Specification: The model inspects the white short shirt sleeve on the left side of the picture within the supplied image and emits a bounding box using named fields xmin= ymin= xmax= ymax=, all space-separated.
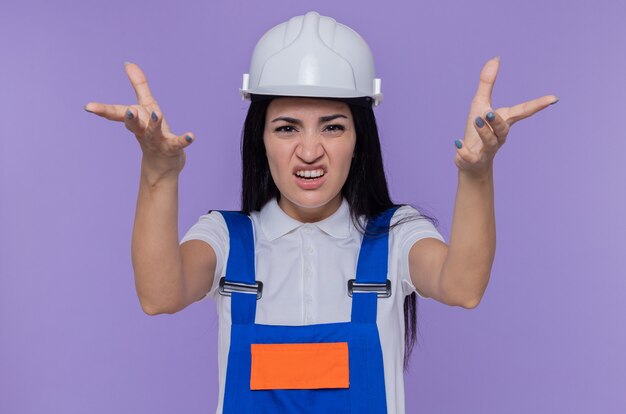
xmin=179 ymin=211 xmax=230 ymax=300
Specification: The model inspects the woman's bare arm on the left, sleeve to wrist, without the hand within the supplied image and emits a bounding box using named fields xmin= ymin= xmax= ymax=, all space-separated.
xmin=132 ymin=165 xmax=216 ymax=315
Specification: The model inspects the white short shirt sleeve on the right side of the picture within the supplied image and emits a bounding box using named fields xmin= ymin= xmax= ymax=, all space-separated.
xmin=390 ymin=205 xmax=445 ymax=299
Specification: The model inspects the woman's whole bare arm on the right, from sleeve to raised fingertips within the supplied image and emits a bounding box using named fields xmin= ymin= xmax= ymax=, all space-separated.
xmin=409 ymin=58 xmax=558 ymax=308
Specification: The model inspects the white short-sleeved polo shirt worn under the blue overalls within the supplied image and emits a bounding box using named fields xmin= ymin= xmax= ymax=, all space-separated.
xmin=180 ymin=199 xmax=444 ymax=414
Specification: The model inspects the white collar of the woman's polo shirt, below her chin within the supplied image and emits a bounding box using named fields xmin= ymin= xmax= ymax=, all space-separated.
xmin=260 ymin=198 xmax=351 ymax=241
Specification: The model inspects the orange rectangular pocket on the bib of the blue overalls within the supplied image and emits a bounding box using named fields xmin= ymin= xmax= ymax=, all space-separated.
xmin=250 ymin=342 xmax=350 ymax=390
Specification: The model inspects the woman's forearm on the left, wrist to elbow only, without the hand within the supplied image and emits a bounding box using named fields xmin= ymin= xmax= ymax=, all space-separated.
xmin=132 ymin=161 xmax=185 ymax=314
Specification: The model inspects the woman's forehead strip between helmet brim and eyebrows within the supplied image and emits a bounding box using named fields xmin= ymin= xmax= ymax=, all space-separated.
xmin=267 ymin=97 xmax=350 ymax=117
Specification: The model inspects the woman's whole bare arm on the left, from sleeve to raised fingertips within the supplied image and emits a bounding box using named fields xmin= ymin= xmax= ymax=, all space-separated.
xmin=85 ymin=60 xmax=215 ymax=315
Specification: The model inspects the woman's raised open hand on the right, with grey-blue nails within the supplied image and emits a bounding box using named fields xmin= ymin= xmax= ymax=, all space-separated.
xmin=454 ymin=57 xmax=558 ymax=176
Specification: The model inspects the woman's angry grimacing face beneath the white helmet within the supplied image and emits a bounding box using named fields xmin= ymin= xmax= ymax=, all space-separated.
xmin=263 ymin=98 xmax=356 ymax=222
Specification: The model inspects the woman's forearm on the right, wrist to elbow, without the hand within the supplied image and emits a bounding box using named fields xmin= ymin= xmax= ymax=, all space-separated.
xmin=439 ymin=167 xmax=496 ymax=307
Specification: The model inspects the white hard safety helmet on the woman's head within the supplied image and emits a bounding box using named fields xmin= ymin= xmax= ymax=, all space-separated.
xmin=240 ymin=11 xmax=383 ymax=105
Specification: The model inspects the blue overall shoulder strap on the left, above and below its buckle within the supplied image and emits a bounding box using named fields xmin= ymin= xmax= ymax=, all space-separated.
xmin=220 ymin=211 xmax=257 ymax=324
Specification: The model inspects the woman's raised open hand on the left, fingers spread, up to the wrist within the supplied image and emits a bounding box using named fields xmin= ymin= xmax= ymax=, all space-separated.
xmin=85 ymin=63 xmax=193 ymax=178
